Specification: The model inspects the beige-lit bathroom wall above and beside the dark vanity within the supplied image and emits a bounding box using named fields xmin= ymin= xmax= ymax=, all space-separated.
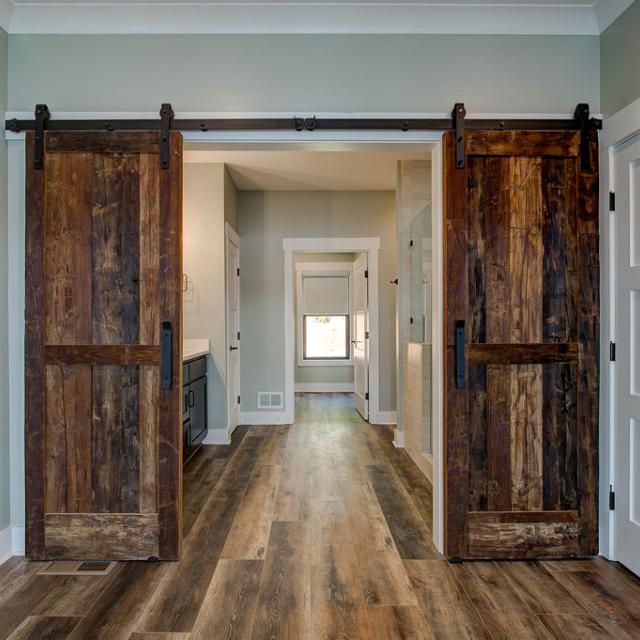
xmin=183 ymin=163 xmax=236 ymax=436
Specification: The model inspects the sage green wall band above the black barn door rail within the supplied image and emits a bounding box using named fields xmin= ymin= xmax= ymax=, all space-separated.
xmin=9 ymin=35 xmax=600 ymax=113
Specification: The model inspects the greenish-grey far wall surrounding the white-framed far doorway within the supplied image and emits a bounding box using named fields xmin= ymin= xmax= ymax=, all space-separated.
xmin=238 ymin=191 xmax=396 ymax=411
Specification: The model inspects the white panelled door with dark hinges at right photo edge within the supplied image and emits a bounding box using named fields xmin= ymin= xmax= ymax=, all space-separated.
xmin=612 ymin=137 xmax=640 ymax=574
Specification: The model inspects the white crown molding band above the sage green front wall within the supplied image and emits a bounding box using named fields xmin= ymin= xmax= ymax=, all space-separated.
xmin=0 ymin=0 xmax=632 ymax=35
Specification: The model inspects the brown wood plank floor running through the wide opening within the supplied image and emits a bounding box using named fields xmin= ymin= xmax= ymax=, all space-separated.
xmin=0 ymin=395 xmax=640 ymax=640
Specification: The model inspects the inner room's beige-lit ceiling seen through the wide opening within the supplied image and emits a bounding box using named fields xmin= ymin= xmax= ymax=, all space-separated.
xmin=184 ymin=150 xmax=426 ymax=191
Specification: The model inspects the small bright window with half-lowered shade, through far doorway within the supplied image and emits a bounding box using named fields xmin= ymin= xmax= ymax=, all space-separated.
xmin=296 ymin=263 xmax=351 ymax=366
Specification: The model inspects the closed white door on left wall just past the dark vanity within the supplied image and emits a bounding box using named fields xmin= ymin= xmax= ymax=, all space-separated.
xmin=226 ymin=227 xmax=240 ymax=429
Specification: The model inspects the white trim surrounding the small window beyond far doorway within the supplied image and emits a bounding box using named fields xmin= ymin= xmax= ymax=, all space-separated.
xmin=294 ymin=261 xmax=353 ymax=367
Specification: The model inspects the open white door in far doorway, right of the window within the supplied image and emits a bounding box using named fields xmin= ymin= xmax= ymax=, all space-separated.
xmin=351 ymin=253 xmax=369 ymax=420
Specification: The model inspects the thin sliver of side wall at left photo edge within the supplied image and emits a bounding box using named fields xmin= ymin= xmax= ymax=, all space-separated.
xmin=0 ymin=29 xmax=11 ymax=531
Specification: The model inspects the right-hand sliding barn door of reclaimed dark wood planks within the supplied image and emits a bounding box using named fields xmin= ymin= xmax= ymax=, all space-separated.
xmin=444 ymin=131 xmax=599 ymax=558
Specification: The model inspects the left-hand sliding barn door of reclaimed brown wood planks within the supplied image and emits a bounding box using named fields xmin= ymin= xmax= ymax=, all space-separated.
xmin=25 ymin=132 xmax=182 ymax=560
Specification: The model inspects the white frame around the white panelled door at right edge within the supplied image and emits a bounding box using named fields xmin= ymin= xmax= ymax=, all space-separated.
xmin=599 ymin=99 xmax=640 ymax=560
